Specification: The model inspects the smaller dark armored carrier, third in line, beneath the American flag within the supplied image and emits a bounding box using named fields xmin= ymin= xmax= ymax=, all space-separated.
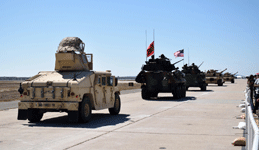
xmin=182 ymin=63 xmax=207 ymax=91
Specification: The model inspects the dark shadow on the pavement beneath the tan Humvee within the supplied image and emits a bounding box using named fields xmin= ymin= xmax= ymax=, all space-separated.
xmin=23 ymin=113 xmax=130 ymax=128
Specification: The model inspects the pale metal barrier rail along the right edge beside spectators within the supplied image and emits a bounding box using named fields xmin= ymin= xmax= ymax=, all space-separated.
xmin=245 ymin=87 xmax=259 ymax=150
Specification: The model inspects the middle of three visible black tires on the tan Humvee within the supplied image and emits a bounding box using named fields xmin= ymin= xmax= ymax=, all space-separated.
xmin=79 ymin=97 xmax=92 ymax=123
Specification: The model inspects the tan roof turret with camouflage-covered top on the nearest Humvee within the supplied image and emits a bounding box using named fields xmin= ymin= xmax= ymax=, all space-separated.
xmin=55 ymin=37 xmax=93 ymax=71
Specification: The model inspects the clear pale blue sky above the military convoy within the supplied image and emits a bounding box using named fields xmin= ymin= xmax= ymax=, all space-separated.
xmin=0 ymin=0 xmax=259 ymax=77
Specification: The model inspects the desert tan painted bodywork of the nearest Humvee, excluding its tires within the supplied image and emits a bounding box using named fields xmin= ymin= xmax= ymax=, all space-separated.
xmin=18 ymin=53 xmax=119 ymax=111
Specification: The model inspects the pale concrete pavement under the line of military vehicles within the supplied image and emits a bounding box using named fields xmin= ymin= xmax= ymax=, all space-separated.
xmin=0 ymin=79 xmax=246 ymax=150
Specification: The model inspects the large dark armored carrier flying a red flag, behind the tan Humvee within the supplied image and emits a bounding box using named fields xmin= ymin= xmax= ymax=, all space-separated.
xmin=135 ymin=54 xmax=186 ymax=99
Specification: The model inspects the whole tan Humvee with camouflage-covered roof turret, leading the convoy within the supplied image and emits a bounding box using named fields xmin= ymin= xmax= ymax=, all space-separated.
xmin=18 ymin=37 xmax=121 ymax=122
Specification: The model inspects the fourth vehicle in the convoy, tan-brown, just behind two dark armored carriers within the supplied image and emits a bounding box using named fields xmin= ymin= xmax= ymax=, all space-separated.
xmin=206 ymin=68 xmax=227 ymax=86
